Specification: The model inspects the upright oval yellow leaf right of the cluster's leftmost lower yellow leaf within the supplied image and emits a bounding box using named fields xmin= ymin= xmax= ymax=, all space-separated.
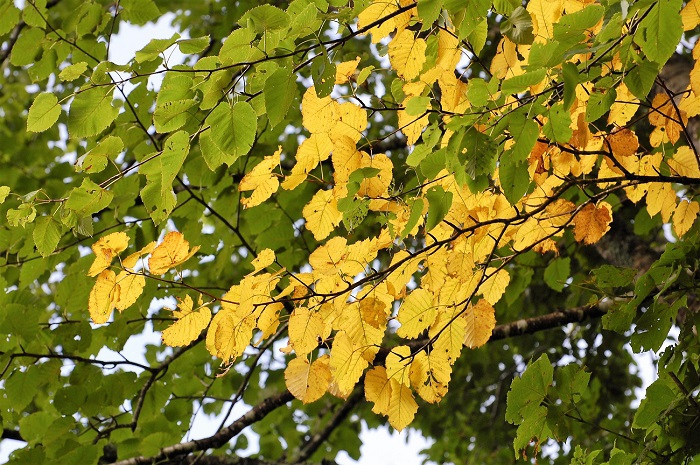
xmin=206 ymin=309 xmax=255 ymax=364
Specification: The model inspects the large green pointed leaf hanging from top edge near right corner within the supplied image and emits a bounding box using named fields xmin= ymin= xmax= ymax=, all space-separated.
xmin=634 ymin=0 xmax=683 ymax=65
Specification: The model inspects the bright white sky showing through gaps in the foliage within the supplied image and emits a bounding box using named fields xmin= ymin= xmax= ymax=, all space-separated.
xmin=0 ymin=10 xmax=677 ymax=465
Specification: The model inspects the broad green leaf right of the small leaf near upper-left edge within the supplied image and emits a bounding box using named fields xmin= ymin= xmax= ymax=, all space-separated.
xmin=68 ymin=87 xmax=119 ymax=138
